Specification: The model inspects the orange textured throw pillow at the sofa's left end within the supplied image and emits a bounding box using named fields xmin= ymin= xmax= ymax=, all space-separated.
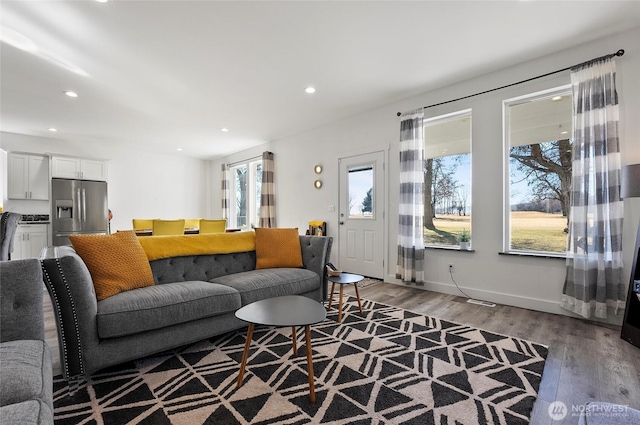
xmin=69 ymin=231 xmax=154 ymax=301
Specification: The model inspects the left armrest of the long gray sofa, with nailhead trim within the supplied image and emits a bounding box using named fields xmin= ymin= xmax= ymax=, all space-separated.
xmin=41 ymin=246 xmax=99 ymax=379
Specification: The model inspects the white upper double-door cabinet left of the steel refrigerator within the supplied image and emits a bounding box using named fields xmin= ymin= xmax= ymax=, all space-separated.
xmin=7 ymin=152 xmax=49 ymax=201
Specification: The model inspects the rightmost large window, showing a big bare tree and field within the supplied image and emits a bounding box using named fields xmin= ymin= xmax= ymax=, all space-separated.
xmin=504 ymin=86 xmax=572 ymax=254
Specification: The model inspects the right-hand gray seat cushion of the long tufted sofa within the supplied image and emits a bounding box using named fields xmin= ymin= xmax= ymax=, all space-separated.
xmin=211 ymin=268 xmax=320 ymax=305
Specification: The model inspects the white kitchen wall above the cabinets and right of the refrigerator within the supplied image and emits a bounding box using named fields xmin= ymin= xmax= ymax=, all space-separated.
xmin=0 ymin=133 xmax=210 ymax=232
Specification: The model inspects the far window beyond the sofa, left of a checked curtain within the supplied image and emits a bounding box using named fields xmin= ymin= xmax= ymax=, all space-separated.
xmin=229 ymin=161 xmax=262 ymax=229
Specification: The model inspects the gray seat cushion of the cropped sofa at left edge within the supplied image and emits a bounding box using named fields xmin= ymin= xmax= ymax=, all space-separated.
xmin=0 ymin=340 xmax=53 ymax=409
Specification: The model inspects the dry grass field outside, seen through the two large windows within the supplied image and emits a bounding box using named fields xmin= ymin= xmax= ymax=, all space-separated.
xmin=424 ymin=211 xmax=567 ymax=252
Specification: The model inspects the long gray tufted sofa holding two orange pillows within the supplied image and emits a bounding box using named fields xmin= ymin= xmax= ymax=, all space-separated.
xmin=41 ymin=236 xmax=332 ymax=380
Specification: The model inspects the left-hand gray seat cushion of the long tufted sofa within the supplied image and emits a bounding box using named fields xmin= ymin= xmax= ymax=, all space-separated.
xmin=97 ymin=281 xmax=240 ymax=338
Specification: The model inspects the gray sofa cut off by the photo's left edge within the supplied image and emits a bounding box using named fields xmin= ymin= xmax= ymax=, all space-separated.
xmin=0 ymin=259 xmax=53 ymax=424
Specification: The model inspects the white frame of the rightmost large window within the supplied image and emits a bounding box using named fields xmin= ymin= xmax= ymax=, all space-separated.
xmin=502 ymin=84 xmax=573 ymax=258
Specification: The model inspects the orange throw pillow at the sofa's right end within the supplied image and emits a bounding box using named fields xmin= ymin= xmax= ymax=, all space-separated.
xmin=256 ymin=227 xmax=303 ymax=269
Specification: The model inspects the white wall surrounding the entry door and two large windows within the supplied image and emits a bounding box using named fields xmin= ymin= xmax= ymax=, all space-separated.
xmin=212 ymin=29 xmax=640 ymax=322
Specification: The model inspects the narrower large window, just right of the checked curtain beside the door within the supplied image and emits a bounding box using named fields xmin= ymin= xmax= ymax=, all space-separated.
xmin=424 ymin=110 xmax=471 ymax=246
